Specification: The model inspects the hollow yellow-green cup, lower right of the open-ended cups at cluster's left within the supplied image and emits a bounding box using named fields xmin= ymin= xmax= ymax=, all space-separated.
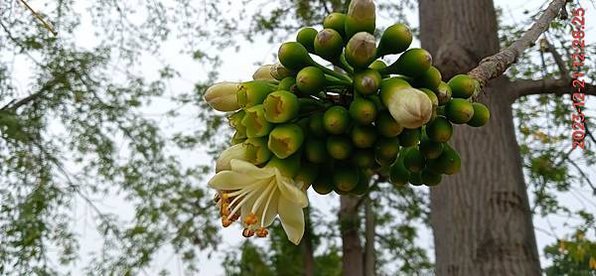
xmin=267 ymin=124 xmax=304 ymax=159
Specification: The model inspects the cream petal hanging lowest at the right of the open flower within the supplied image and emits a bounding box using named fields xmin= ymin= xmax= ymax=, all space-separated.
xmin=277 ymin=197 xmax=304 ymax=245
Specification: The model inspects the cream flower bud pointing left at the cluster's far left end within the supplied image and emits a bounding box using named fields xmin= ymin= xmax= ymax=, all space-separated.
xmin=203 ymin=82 xmax=240 ymax=112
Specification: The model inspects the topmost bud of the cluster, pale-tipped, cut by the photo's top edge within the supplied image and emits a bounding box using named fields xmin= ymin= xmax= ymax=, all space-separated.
xmin=345 ymin=0 xmax=376 ymax=38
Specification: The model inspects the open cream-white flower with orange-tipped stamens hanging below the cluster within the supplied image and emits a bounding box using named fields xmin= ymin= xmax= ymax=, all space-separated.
xmin=209 ymin=159 xmax=308 ymax=244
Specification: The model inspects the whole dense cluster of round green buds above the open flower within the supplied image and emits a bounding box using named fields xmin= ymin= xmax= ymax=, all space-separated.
xmin=203 ymin=1 xmax=490 ymax=194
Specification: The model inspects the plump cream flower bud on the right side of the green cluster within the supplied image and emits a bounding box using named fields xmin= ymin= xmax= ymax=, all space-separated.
xmin=382 ymin=87 xmax=433 ymax=129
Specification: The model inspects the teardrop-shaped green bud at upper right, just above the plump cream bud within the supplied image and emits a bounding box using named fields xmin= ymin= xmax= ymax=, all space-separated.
xmin=381 ymin=48 xmax=433 ymax=78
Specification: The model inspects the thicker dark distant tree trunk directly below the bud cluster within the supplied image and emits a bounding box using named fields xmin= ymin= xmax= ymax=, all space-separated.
xmin=339 ymin=196 xmax=364 ymax=276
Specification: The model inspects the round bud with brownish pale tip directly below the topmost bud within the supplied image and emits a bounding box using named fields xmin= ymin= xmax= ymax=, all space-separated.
xmin=345 ymin=32 xmax=377 ymax=68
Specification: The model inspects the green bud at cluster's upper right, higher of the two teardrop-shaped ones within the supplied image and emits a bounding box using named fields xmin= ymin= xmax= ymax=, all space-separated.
xmin=377 ymin=23 xmax=412 ymax=57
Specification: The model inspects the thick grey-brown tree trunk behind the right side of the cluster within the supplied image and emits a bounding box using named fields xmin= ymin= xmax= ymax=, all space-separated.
xmin=419 ymin=0 xmax=540 ymax=276
